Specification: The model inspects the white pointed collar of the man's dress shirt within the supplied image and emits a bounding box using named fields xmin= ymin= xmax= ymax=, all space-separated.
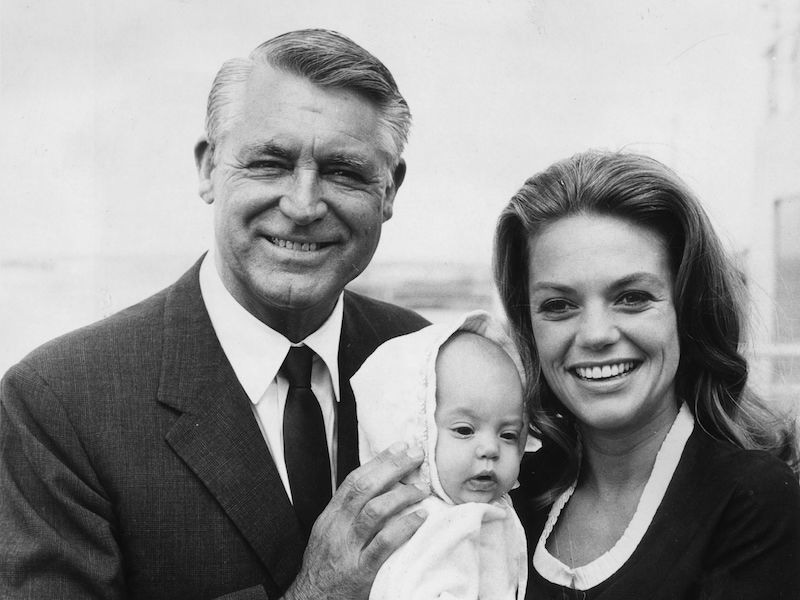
xmin=200 ymin=251 xmax=344 ymax=404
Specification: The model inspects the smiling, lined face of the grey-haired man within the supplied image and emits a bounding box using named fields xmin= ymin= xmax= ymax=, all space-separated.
xmin=200 ymin=66 xmax=397 ymax=335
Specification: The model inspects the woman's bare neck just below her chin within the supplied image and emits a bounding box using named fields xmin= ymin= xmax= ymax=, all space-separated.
xmin=580 ymin=405 xmax=678 ymax=497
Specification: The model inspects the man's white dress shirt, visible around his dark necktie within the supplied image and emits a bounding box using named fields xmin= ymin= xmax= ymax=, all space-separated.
xmin=200 ymin=251 xmax=343 ymax=499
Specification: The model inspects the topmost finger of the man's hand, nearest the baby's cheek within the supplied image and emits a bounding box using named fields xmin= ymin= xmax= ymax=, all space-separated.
xmin=331 ymin=442 xmax=423 ymax=517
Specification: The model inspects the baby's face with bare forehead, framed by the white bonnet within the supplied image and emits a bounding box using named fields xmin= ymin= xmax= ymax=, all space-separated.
xmin=436 ymin=333 xmax=525 ymax=504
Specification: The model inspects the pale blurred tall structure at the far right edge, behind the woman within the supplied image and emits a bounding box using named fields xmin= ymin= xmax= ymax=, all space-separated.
xmin=747 ymin=0 xmax=800 ymax=407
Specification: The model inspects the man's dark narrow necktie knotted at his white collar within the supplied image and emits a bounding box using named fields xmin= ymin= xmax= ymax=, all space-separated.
xmin=280 ymin=346 xmax=331 ymax=538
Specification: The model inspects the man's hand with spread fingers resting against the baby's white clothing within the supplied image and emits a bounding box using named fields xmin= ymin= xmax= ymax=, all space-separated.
xmin=284 ymin=443 xmax=427 ymax=600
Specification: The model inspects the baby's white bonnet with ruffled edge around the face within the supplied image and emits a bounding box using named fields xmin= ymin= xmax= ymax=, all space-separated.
xmin=350 ymin=311 xmax=538 ymax=504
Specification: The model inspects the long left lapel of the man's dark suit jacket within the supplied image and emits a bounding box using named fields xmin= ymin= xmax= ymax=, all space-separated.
xmin=159 ymin=265 xmax=305 ymax=590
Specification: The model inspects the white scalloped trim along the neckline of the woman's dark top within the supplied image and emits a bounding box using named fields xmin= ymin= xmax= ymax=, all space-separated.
xmin=533 ymin=404 xmax=694 ymax=590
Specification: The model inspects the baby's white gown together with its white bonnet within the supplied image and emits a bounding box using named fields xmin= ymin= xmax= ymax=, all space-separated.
xmin=351 ymin=311 xmax=538 ymax=600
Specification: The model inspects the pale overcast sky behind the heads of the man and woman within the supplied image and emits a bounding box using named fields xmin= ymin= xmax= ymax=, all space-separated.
xmin=0 ymin=0 xmax=770 ymax=270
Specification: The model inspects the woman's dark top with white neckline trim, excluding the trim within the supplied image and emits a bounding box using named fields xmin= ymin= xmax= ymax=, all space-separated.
xmin=514 ymin=425 xmax=800 ymax=600
